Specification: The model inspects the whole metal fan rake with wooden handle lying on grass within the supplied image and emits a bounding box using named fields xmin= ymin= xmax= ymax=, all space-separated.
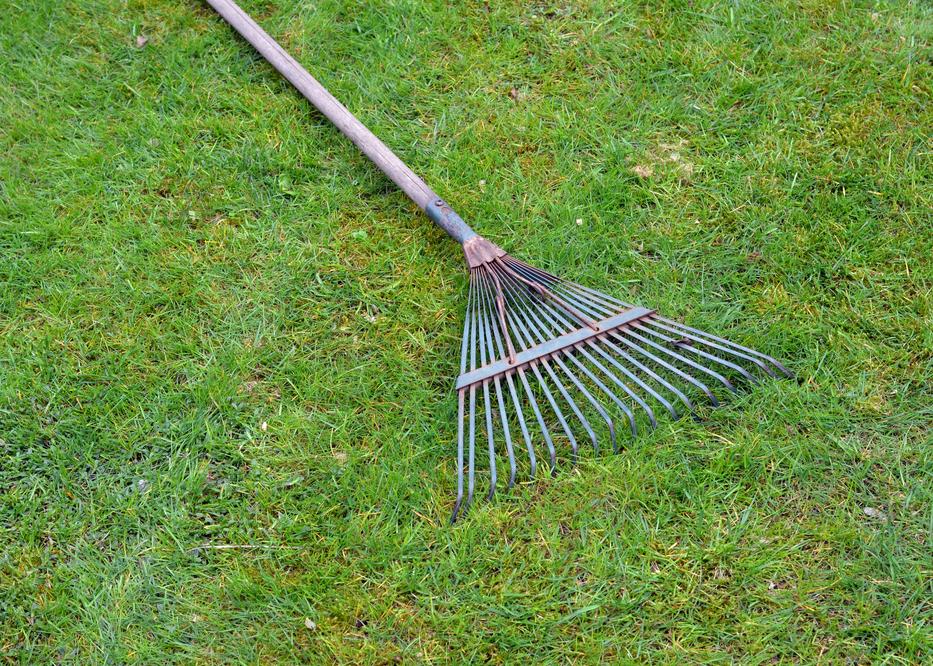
xmin=207 ymin=0 xmax=792 ymax=522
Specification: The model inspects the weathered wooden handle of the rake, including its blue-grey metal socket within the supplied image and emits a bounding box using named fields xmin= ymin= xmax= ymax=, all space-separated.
xmin=207 ymin=0 xmax=476 ymax=245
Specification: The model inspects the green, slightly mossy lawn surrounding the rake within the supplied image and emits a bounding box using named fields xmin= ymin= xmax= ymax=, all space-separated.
xmin=0 ymin=0 xmax=933 ymax=664
